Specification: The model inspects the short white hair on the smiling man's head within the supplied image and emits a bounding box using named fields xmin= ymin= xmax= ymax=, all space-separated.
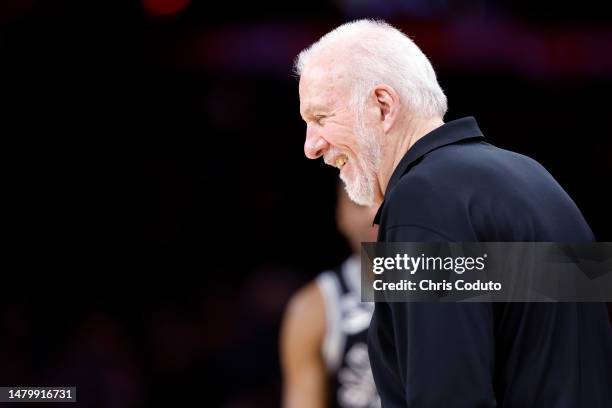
xmin=294 ymin=20 xmax=447 ymax=117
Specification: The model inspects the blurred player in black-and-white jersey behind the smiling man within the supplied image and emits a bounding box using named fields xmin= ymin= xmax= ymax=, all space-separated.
xmin=281 ymin=186 xmax=380 ymax=408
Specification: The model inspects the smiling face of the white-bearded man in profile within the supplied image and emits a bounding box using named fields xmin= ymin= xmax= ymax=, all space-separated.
xmin=300 ymin=64 xmax=380 ymax=206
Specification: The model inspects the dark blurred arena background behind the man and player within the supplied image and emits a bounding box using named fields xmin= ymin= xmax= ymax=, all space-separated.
xmin=0 ymin=0 xmax=612 ymax=407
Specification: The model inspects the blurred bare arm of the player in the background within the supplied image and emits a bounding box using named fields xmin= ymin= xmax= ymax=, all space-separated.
xmin=281 ymin=283 xmax=327 ymax=408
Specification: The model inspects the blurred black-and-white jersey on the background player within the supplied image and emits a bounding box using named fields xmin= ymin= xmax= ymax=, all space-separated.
xmin=316 ymin=256 xmax=380 ymax=408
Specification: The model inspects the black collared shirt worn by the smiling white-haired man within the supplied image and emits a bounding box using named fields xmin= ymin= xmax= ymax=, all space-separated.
xmin=369 ymin=117 xmax=612 ymax=408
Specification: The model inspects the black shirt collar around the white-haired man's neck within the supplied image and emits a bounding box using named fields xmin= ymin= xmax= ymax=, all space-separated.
xmin=374 ymin=116 xmax=484 ymax=224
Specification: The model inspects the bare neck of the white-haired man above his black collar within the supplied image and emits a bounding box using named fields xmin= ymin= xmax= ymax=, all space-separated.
xmin=379 ymin=117 xmax=444 ymax=202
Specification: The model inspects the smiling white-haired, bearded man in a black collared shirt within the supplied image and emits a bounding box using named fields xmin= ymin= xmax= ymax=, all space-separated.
xmin=295 ymin=20 xmax=612 ymax=408
